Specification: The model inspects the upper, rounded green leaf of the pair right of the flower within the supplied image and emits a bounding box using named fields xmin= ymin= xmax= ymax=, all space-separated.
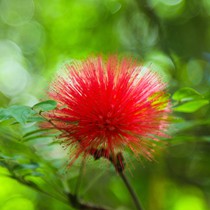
xmin=172 ymin=87 xmax=203 ymax=102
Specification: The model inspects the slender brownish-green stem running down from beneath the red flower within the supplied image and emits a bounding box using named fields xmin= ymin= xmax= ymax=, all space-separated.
xmin=119 ymin=171 xmax=143 ymax=210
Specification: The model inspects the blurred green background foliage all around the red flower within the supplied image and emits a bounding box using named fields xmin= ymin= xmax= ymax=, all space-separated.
xmin=0 ymin=0 xmax=210 ymax=210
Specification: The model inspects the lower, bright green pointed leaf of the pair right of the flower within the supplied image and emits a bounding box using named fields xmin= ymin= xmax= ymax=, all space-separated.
xmin=174 ymin=100 xmax=209 ymax=113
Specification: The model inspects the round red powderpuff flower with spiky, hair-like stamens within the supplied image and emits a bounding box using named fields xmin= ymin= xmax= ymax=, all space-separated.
xmin=46 ymin=57 xmax=170 ymax=165
